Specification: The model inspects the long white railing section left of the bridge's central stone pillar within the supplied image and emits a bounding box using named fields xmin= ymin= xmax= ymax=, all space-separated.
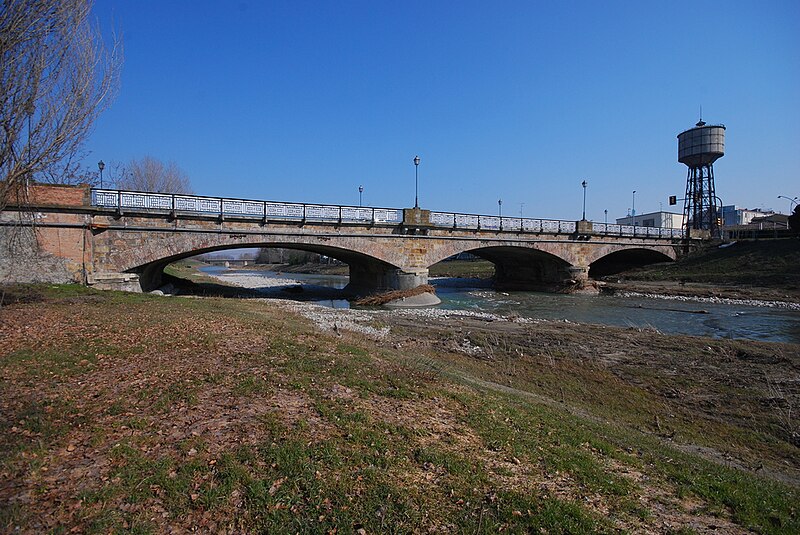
xmin=92 ymin=189 xmax=403 ymax=224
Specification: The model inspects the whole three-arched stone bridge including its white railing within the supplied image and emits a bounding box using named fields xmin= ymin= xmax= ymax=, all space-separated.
xmin=0 ymin=185 xmax=686 ymax=294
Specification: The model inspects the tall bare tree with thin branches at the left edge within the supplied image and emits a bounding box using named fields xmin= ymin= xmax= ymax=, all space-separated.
xmin=0 ymin=0 xmax=122 ymax=205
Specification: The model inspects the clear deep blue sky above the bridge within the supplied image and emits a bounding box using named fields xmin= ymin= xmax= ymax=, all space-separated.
xmin=86 ymin=0 xmax=800 ymax=221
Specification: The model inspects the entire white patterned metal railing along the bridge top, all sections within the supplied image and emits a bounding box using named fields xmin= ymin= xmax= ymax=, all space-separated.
xmin=92 ymin=189 xmax=685 ymax=238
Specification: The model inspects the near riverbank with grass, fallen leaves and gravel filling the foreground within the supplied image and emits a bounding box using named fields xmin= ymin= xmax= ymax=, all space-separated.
xmin=0 ymin=286 xmax=800 ymax=533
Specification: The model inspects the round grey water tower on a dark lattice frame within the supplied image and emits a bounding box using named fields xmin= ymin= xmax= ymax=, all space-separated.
xmin=678 ymin=119 xmax=725 ymax=237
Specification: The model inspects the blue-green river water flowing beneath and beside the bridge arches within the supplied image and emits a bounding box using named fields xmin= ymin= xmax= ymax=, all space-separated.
xmin=201 ymin=266 xmax=800 ymax=343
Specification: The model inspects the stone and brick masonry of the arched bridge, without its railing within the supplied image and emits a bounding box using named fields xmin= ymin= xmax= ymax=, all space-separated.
xmin=0 ymin=185 xmax=681 ymax=293
